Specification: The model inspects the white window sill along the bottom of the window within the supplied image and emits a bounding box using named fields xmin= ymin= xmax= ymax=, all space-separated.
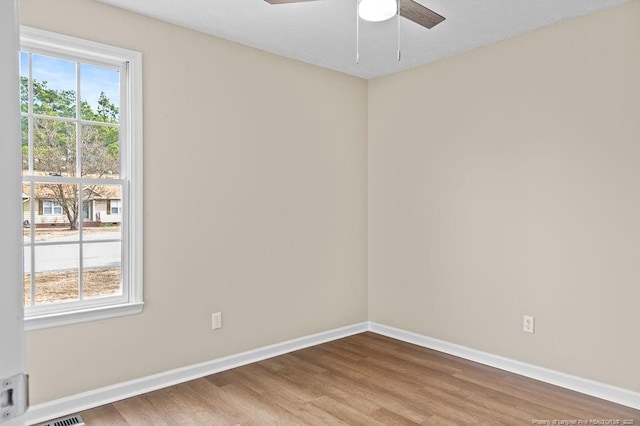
xmin=24 ymin=302 xmax=144 ymax=331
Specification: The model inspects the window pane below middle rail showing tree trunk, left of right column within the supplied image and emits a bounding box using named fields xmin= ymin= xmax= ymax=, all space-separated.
xmin=33 ymin=183 xmax=79 ymax=242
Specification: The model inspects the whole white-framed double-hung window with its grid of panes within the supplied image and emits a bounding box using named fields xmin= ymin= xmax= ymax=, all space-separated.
xmin=20 ymin=27 xmax=142 ymax=329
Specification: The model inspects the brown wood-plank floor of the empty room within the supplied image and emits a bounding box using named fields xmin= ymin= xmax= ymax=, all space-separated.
xmin=80 ymin=333 xmax=640 ymax=426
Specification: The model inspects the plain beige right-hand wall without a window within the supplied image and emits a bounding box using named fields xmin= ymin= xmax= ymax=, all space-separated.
xmin=368 ymin=0 xmax=640 ymax=391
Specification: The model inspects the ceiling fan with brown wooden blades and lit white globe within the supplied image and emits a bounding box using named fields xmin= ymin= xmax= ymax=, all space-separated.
xmin=265 ymin=0 xmax=445 ymax=28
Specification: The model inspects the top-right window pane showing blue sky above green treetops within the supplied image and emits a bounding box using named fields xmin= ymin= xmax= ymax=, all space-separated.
xmin=80 ymin=64 xmax=120 ymax=123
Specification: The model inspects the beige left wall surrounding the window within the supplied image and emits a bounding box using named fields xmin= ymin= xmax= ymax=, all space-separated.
xmin=21 ymin=0 xmax=367 ymax=404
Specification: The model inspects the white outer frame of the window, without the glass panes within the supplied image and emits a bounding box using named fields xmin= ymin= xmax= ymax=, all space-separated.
xmin=21 ymin=26 xmax=143 ymax=330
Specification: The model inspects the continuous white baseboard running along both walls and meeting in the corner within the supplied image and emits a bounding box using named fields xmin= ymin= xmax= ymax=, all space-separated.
xmin=24 ymin=322 xmax=640 ymax=424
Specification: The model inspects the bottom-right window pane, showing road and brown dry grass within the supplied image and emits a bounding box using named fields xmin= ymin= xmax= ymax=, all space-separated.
xmin=83 ymin=242 xmax=122 ymax=299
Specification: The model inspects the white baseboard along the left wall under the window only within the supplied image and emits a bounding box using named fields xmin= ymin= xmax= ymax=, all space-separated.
xmin=24 ymin=322 xmax=369 ymax=425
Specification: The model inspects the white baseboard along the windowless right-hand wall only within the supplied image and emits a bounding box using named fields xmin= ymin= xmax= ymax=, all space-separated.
xmin=369 ymin=322 xmax=640 ymax=410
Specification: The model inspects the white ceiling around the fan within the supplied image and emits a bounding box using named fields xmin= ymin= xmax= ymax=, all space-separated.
xmin=100 ymin=0 xmax=628 ymax=79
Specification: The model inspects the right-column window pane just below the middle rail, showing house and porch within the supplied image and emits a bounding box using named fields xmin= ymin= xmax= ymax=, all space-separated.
xmin=82 ymin=185 xmax=122 ymax=241
